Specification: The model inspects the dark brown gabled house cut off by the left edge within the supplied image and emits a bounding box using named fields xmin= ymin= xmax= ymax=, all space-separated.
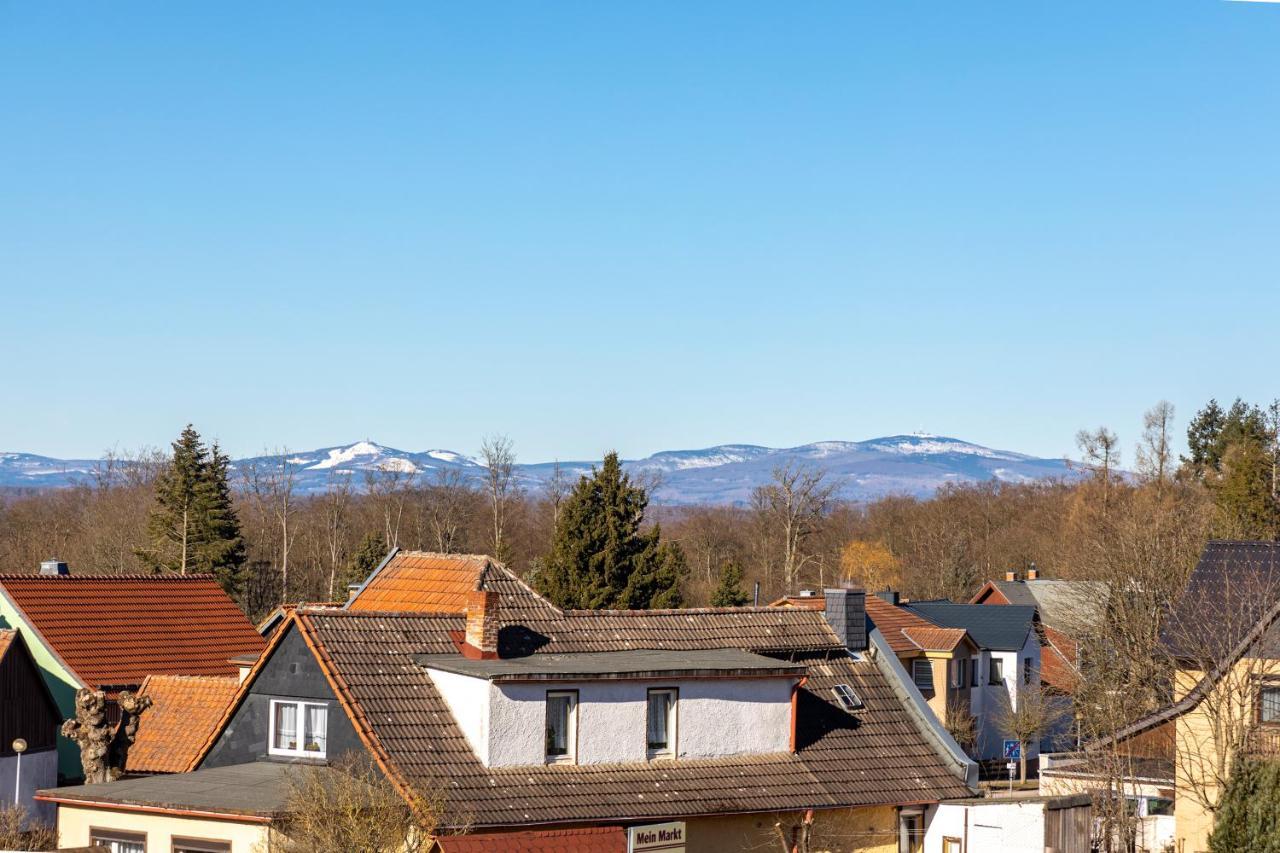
xmin=0 ymin=630 xmax=61 ymax=821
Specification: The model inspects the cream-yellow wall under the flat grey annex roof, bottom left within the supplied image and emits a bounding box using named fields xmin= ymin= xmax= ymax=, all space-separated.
xmin=58 ymin=804 xmax=269 ymax=853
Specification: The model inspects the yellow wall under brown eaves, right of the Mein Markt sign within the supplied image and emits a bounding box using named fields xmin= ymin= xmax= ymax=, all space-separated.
xmin=686 ymin=806 xmax=897 ymax=853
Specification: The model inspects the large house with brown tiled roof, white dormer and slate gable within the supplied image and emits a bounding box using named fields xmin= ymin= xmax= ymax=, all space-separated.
xmin=42 ymin=552 xmax=977 ymax=853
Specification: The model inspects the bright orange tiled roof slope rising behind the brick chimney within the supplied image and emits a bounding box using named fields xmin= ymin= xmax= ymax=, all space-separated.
xmin=347 ymin=551 xmax=489 ymax=613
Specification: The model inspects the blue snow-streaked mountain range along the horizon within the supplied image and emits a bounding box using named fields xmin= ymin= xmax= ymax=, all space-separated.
xmin=0 ymin=434 xmax=1074 ymax=505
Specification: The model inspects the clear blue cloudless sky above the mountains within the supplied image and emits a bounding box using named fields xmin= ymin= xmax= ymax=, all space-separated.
xmin=0 ymin=0 xmax=1280 ymax=461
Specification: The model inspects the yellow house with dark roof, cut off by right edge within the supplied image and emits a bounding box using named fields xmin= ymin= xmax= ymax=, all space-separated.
xmin=1051 ymin=540 xmax=1280 ymax=853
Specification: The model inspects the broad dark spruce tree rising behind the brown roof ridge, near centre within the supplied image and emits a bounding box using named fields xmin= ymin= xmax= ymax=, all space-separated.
xmin=535 ymin=453 xmax=689 ymax=610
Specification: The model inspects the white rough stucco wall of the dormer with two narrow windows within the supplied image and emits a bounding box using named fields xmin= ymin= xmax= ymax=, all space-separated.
xmin=431 ymin=671 xmax=794 ymax=767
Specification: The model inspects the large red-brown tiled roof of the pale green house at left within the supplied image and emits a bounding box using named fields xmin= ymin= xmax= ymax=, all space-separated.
xmin=0 ymin=575 xmax=266 ymax=688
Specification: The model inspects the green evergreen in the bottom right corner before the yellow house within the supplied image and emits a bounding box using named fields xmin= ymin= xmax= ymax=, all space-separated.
xmin=1208 ymin=760 xmax=1280 ymax=853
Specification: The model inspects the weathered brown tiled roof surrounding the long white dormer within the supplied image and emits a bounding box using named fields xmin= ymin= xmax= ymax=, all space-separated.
xmin=288 ymin=608 xmax=969 ymax=826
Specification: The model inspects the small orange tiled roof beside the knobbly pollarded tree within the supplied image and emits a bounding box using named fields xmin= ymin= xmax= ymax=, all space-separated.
xmin=127 ymin=675 xmax=239 ymax=774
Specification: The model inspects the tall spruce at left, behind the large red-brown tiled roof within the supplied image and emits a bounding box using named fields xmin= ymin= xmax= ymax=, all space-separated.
xmin=137 ymin=424 xmax=246 ymax=596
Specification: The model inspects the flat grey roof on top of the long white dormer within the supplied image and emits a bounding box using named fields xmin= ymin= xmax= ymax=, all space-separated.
xmin=413 ymin=648 xmax=805 ymax=681
